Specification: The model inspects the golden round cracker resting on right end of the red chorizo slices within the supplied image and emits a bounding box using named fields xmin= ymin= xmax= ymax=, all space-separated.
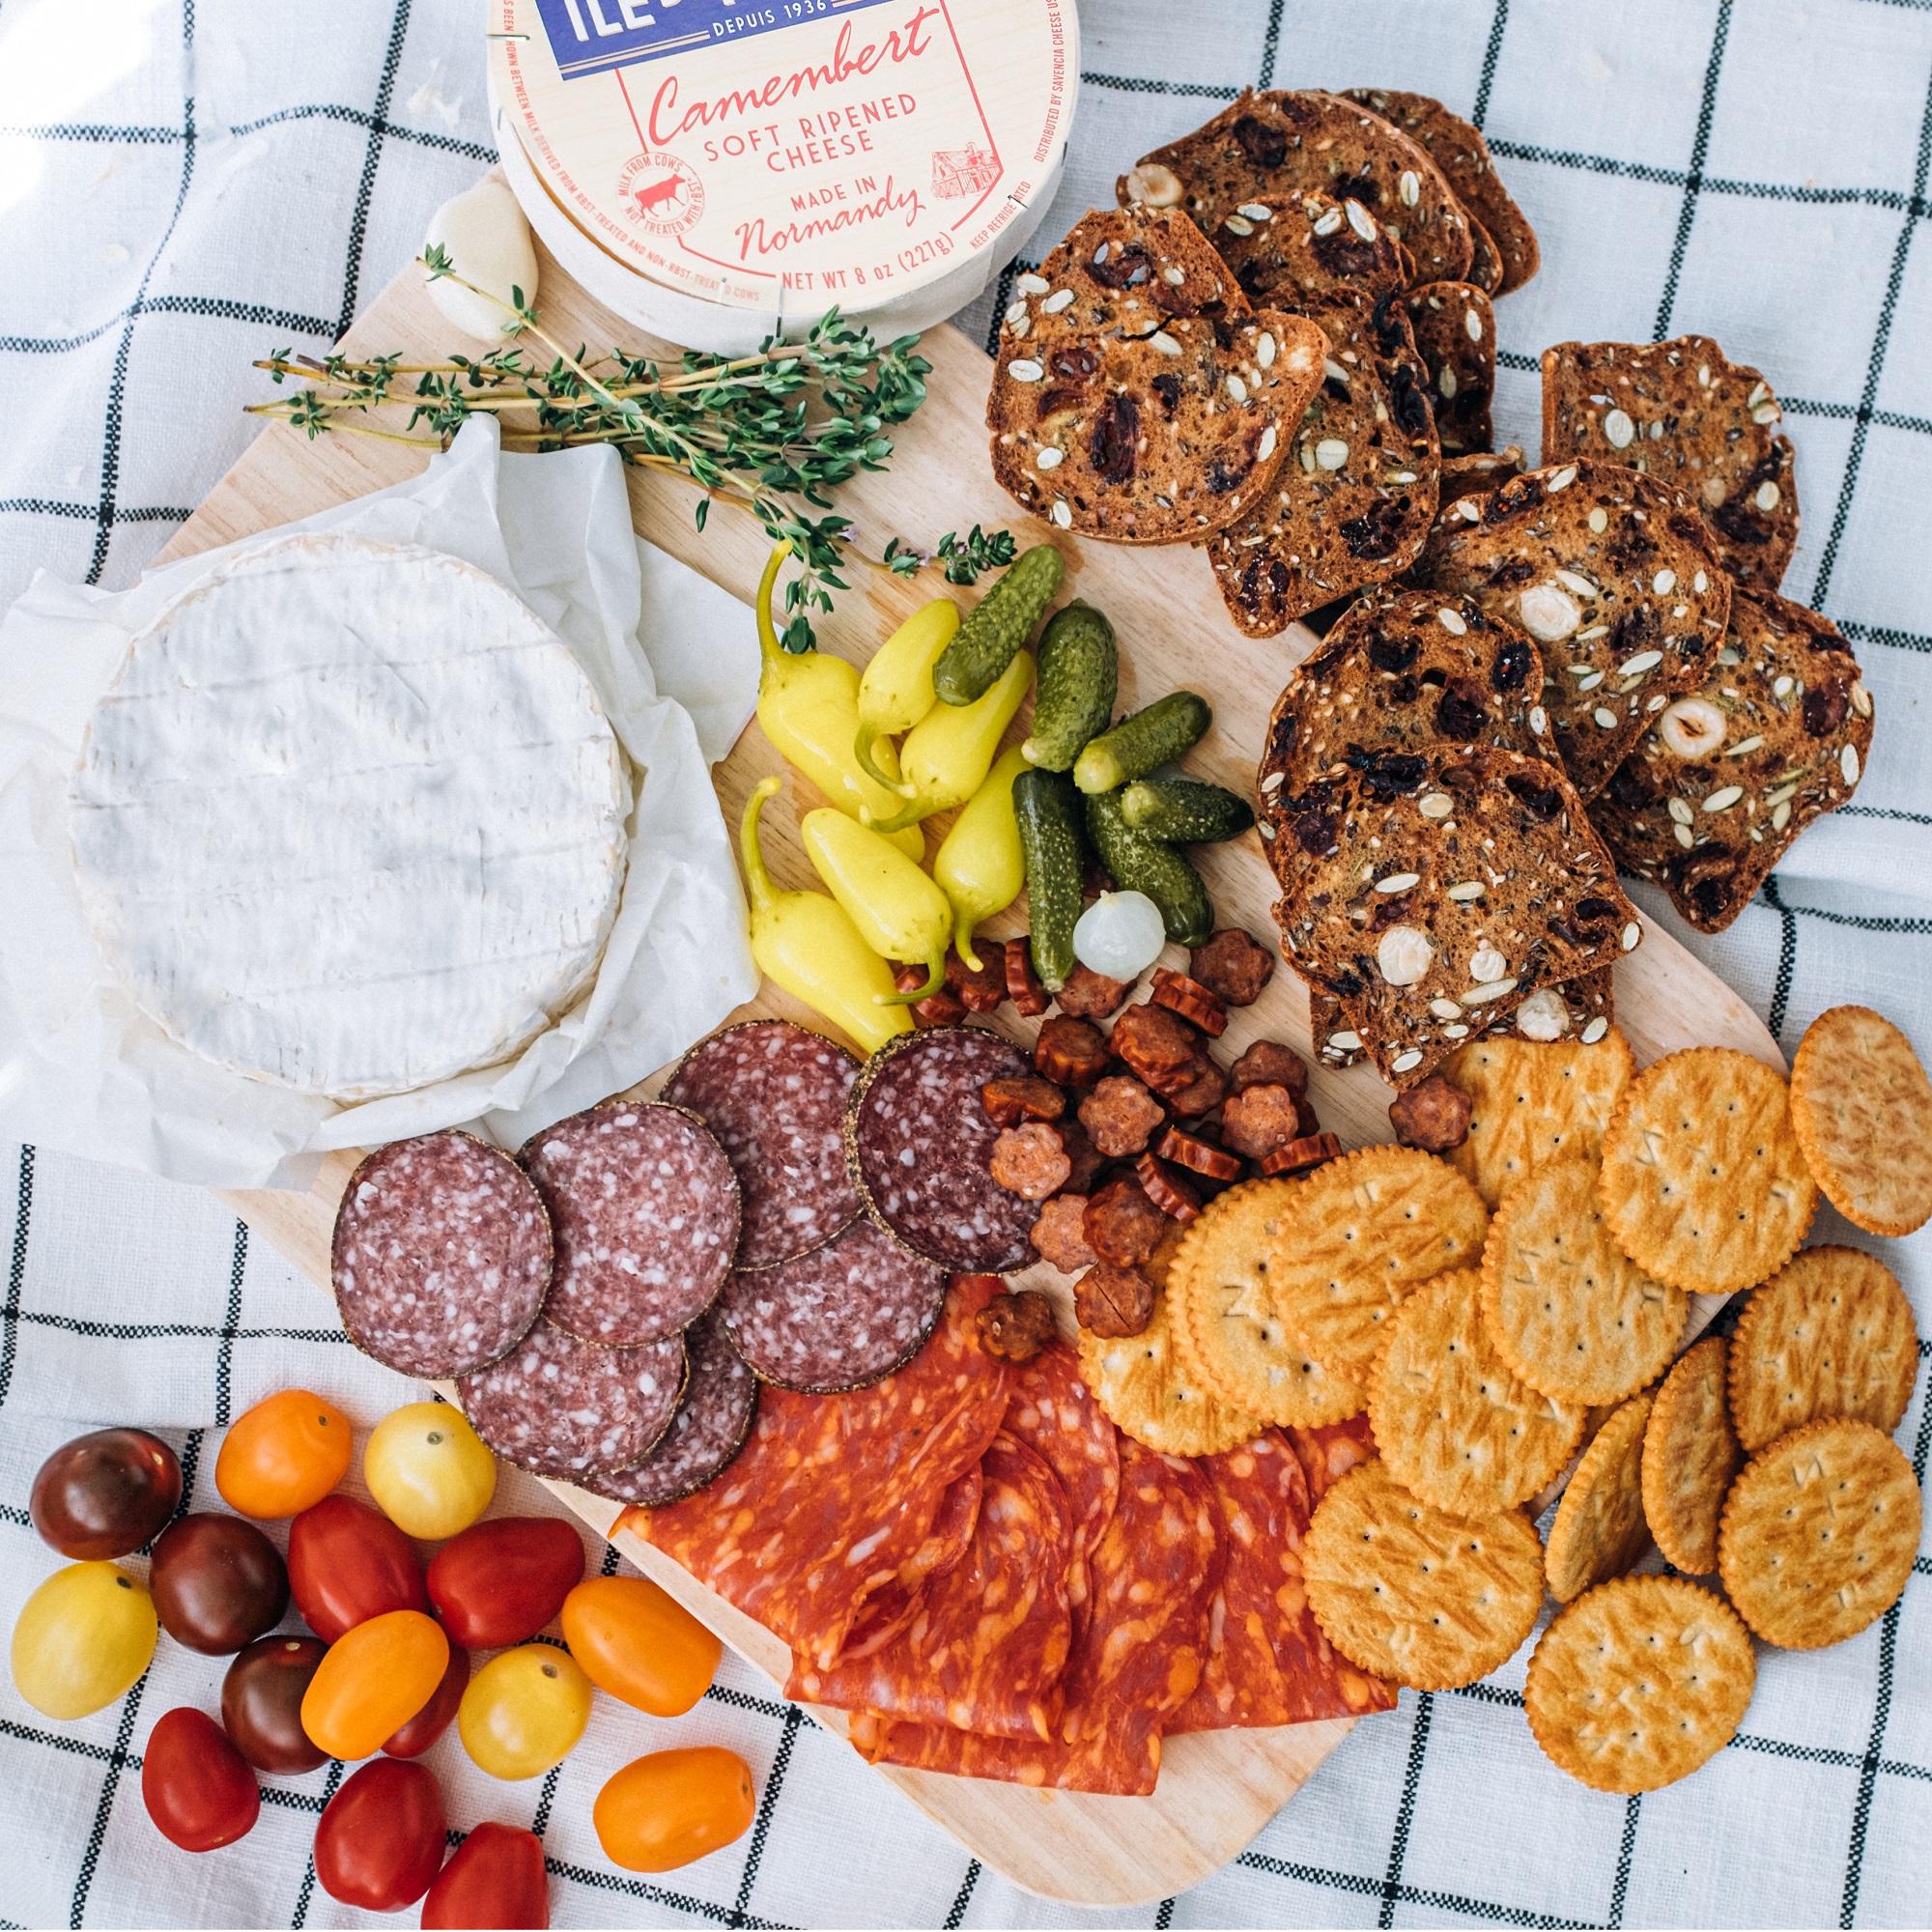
xmin=1302 ymin=1457 xmax=1544 ymax=1690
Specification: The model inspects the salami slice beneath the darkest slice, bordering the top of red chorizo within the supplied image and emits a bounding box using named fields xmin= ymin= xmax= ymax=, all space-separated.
xmin=719 ymin=1221 xmax=947 ymax=1395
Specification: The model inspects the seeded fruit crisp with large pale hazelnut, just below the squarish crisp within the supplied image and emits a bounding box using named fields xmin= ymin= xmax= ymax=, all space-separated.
xmin=1414 ymin=462 xmax=1731 ymax=800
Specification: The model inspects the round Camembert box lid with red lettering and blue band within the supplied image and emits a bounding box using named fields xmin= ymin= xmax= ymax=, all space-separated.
xmin=489 ymin=0 xmax=1078 ymax=317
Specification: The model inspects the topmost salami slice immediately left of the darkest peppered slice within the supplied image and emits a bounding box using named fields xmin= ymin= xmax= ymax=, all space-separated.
xmin=665 ymin=1020 xmax=860 ymax=1271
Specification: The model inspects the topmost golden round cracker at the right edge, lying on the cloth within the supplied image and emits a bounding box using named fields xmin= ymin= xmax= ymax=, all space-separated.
xmin=1791 ymin=1007 xmax=1932 ymax=1235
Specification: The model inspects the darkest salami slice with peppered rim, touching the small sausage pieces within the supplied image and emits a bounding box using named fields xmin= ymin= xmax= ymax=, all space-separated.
xmin=846 ymin=1026 xmax=1037 ymax=1275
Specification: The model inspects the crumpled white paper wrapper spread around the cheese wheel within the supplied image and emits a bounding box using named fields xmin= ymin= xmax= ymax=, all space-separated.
xmin=0 ymin=421 xmax=757 ymax=1188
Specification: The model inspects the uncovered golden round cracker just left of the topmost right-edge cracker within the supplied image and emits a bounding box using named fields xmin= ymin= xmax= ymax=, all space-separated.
xmin=1600 ymin=1047 xmax=1818 ymax=1294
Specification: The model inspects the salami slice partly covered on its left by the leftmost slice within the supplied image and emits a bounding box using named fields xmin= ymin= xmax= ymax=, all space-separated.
xmin=518 ymin=1101 xmax=738 ymax=1349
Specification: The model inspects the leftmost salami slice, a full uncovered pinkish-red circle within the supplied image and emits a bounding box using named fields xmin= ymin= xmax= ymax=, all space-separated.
xmin=330 ymin=1132 xmax=551 ymax=1381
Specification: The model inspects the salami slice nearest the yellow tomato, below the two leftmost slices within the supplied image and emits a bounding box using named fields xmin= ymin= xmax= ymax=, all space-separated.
xmin=456 ymin=1321 xmax=684 ymax=1482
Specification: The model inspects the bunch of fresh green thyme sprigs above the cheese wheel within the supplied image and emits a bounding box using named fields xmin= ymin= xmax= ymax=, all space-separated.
xmin=249 ymin=247 xmax=931 ymax=651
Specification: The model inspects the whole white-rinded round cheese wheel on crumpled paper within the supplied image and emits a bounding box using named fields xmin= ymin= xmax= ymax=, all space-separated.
xmin=70 ymin=535 xmax=630 ymax=1101
